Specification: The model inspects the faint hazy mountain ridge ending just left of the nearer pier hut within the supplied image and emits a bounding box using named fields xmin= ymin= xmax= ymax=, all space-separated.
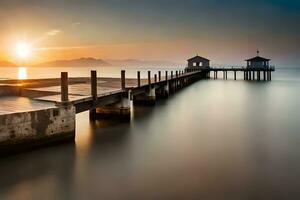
xmin=106 ymin=59 xmax=184 ymax=67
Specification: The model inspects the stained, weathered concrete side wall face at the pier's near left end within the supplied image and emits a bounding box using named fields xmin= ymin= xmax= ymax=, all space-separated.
xmin=0 ymin=105 xmax=75 ymax=153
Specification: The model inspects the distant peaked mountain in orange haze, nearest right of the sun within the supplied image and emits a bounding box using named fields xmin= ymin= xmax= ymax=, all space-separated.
xmin=32 ymin=58 xmax=111 ymax=67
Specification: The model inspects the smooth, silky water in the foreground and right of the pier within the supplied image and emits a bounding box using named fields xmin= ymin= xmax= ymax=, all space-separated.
xmin=0 ymin=69 xmax=300 ymax=200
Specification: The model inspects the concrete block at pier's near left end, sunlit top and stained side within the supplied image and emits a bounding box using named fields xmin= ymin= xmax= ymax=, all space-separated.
xmin=0 ymin=96 xmax=75 ymax=154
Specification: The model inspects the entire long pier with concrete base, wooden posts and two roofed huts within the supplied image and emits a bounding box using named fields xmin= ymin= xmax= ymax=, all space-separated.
xmin=0 ymin=56 xmax=275 ymax=154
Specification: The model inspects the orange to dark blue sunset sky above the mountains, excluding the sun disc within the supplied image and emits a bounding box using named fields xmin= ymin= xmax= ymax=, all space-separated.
xmin=0 ymin=0 xmax=300 ymax=67
